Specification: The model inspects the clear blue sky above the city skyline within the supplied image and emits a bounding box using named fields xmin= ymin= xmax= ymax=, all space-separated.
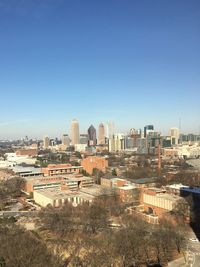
xmin=0 ymin=0 xmax=200 ymax=138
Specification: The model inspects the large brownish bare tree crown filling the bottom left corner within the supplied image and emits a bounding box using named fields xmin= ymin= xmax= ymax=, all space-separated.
xmin=0 ymin=225 xmax=62 ymax=267
